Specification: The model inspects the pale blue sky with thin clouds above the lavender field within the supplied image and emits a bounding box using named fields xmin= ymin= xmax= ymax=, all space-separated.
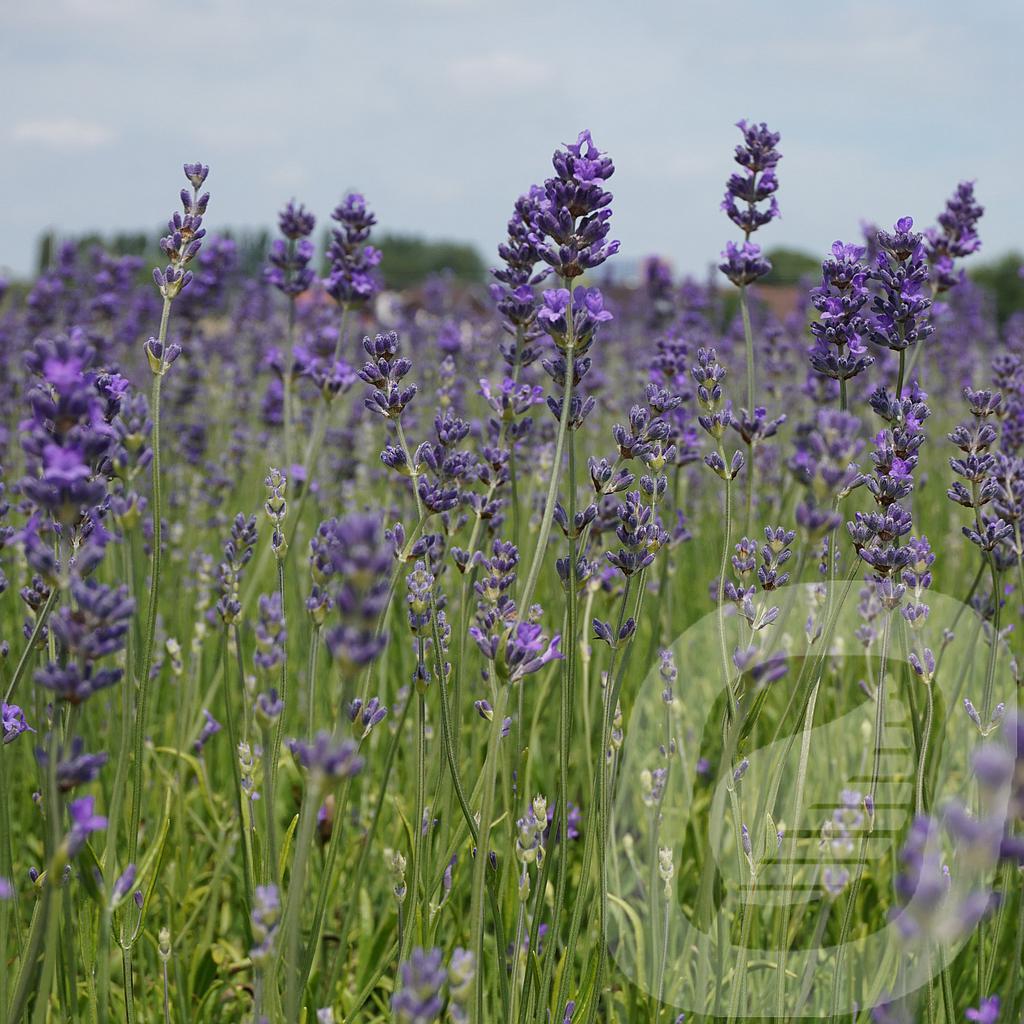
xmin=0 ymin=0 xmax=1024 ymax=274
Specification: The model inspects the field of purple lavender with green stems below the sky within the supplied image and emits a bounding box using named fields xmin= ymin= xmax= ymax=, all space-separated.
xmin=0 ymin=120 xmax=1024 ymax=1024
